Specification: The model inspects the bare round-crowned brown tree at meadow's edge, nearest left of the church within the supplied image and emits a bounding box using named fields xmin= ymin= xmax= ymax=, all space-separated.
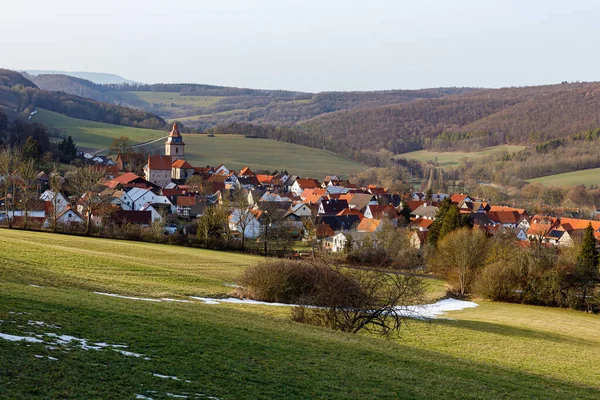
xmin=69 ymin=166 xmax=105 ymax=235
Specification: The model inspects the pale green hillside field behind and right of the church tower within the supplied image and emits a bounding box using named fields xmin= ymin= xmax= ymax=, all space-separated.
xmin=148 ymin=134 xmax=365 ymax=179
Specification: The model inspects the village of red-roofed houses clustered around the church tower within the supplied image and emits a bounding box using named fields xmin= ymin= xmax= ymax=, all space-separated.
xmin=4 ymin=124 xmax=600 ymax=252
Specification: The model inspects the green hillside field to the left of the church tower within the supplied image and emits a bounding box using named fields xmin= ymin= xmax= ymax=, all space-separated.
xmin=32 ymin=108 xmax=168 ymax=150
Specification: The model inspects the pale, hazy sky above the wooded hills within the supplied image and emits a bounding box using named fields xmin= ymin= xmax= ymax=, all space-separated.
xmin=0 ymin=0 xmax=600 ymax=92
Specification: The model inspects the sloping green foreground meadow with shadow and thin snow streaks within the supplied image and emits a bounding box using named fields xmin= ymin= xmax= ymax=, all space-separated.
xmin=0 ymin=230 xmax=600 ymax=399
